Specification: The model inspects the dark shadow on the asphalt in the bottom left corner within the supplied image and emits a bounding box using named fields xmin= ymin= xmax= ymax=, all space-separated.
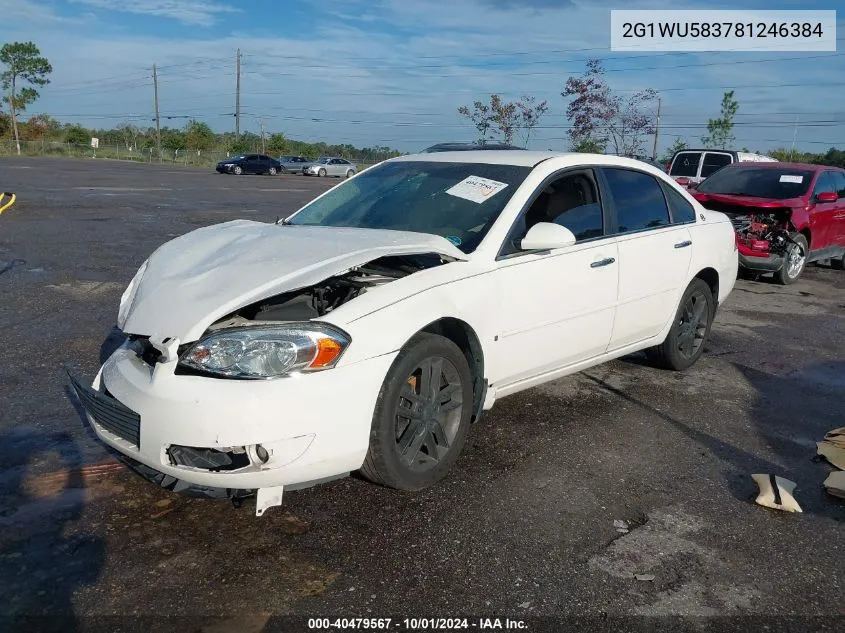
xmin=0 ymin=428 xmax=105 ymax=631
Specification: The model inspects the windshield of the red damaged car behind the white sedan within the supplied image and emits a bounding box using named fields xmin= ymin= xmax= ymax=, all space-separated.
xmin=698 ymin=166 xmax=813 ymax=200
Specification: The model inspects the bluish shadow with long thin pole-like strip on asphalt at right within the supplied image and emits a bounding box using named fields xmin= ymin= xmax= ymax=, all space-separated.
xmin=582 ymin=361 xmax=845 ymax=520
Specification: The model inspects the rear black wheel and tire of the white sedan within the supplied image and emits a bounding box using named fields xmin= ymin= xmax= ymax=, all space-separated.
xmin=646 ymin=279 xmax=716 ymax=371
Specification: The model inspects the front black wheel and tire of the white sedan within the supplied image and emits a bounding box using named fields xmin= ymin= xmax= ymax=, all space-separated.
xmin=360 ymin=334 xmax=473 ymax=490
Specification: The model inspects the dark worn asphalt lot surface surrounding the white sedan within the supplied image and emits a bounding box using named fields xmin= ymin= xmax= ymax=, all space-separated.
xmin=0 ymin=159 xmax=845 ymax=632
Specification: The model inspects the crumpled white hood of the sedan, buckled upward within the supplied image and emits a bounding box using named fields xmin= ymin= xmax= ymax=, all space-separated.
xmin=122 ymin=220 xmax=467 ymax=343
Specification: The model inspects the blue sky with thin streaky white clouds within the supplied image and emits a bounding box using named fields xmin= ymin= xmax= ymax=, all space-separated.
xmin=0 ymin=0 xmax=845 ymax=152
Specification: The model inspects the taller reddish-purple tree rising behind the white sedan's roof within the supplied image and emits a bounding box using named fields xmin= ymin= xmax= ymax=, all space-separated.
xmin=560 ymin=59 xmax=615 ymax=153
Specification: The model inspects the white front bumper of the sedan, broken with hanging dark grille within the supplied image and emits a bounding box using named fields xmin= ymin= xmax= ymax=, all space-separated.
xmin=74 ymin=342 xmax=395 ymax=496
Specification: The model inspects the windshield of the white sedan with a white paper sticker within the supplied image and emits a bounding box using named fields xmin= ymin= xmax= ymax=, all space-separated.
xmin=289 ymin=161 xmax=531 ymax=253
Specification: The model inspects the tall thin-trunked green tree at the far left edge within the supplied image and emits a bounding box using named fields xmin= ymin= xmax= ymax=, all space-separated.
xmin=0 ymin=42 xmax=53 ymax=155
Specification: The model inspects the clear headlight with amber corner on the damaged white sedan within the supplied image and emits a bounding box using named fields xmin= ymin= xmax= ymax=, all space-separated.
xmin=179 ymin=323 xmax=350 ymax=378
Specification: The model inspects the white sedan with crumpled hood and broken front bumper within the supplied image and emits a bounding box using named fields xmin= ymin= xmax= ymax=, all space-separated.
xmin=71 ymin=151 xmax=737 ymax=515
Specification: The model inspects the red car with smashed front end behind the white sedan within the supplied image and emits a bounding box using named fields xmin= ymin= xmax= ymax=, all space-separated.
xmin=692 ymin=163 xmax=845 ymax=284
